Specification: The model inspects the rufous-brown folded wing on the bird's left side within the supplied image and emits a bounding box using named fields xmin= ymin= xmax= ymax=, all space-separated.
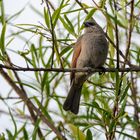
xmin=70 ymin=36 xmax=83 ymax=82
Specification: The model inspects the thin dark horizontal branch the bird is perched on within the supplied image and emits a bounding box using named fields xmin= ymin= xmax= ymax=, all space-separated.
xmin=0 ymin=64 xmax=140 ymax=72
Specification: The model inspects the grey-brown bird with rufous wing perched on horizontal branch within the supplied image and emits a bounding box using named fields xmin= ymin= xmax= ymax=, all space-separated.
xmin=63 ymin=19 xmax=108 ymax=114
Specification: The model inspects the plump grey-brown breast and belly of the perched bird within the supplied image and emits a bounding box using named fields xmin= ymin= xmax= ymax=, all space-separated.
xmin=78 ymin=33 xmax=108 ymax=67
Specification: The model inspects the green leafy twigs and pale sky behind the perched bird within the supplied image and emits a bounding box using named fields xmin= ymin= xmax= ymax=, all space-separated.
xmin=0 ymin=0 xmax=140 ymax=140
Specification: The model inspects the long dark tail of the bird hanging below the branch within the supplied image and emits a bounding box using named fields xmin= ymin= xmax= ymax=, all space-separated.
xmin=63 ymin=81 xmax=82 ymax=114
